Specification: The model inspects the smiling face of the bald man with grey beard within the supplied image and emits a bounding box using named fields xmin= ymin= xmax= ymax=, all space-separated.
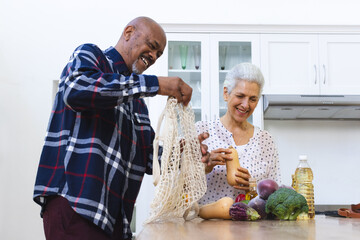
xmin=128 ymin=26 xmax=166 ymax=74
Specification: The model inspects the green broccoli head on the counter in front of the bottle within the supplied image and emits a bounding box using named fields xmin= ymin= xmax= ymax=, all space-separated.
xmin=265 ymin=188 xmax=309 ymax=220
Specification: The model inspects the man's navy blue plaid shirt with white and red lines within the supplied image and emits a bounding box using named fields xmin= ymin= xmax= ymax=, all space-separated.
xmin=33 ymin=44 xmax=159 ymax=238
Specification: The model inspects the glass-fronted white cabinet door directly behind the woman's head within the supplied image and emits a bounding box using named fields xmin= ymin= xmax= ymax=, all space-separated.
xmin=210 ymin=34 xmax=263 ymax=127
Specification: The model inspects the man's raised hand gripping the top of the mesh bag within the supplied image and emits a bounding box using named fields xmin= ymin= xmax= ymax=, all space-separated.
xmin=158 ymin=77 xmax=192 ymax=106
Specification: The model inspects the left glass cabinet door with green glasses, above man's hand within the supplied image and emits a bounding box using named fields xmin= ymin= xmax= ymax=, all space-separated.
xmin=167 ymin=34 xmax=209 ymax=121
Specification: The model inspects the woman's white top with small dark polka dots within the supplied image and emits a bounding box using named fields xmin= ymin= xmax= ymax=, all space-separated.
xmin=196 ymin=119 xmax=281 ymax=205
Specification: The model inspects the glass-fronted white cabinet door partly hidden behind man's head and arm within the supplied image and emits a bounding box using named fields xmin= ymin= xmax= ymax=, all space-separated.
xmin=149 ymin=33 xmax=210 ymax=126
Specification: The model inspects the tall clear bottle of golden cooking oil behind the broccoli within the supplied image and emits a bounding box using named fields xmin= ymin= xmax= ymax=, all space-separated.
xmin=294 ymin=155 xmax=315 ymax=219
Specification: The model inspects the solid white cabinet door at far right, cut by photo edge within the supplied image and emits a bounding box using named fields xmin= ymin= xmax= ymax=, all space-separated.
xmin=319 ymin=35 xmax=360 ymax=94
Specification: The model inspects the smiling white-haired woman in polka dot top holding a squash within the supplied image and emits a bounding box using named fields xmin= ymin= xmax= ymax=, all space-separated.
xmin=196 ymin=63 xmax=280 ymax=205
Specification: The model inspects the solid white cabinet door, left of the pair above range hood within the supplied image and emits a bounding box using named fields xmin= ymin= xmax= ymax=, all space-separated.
xmin=261 ymin=34 xmax=320 ymax=94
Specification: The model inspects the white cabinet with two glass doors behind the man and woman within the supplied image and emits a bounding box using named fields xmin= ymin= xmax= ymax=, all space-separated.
xmin=149 ymin=33 xmax=263 ymax=128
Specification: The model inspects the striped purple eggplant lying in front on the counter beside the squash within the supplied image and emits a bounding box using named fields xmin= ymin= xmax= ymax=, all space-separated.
xmin=229 ymin=202 xmax=261 ymax=221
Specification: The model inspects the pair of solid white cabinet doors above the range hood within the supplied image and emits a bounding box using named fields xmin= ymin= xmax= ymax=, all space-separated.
xmin=261 ymin=34 xmax=360 ymax=95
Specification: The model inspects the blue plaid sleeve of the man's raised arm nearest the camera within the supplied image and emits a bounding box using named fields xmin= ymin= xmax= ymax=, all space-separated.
xmin=62 ymin=44 xmax=159 ymax=111
